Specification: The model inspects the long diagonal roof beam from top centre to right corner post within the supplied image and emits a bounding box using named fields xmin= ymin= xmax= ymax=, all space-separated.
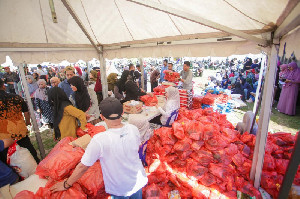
xmin=126 ymin=0 xmax=268 ymax=46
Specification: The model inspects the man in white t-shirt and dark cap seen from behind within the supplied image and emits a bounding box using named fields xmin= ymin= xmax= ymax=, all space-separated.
xmin=51 ymin=97 xmax=148 ymax=199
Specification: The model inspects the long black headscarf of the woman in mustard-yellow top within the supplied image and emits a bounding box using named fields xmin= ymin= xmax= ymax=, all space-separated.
xmin=48 ymin=87 xmax=72 ymax=139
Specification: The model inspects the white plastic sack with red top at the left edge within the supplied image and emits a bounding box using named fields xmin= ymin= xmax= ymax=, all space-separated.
xmin=7 ymin=142 xmax=37 ymax=178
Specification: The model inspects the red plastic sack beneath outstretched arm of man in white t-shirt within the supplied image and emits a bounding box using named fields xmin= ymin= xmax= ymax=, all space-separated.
xmin=77 ymin=161 xmax=104 ymax=196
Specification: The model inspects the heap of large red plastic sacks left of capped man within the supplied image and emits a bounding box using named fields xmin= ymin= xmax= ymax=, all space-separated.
xmin=29 ymin=131 xmax=109 ymax=198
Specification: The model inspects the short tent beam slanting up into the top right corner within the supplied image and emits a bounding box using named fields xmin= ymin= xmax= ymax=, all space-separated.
xmin=274 ymin=3 xmax=300 ymax=38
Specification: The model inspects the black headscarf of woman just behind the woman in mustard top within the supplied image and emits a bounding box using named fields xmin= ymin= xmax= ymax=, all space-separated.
xmin=68 ymin=76 xmax=91 ymax=112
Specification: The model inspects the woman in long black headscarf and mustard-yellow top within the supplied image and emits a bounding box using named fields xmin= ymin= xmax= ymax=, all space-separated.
xmin=48 ymin=87 xmax=86 ymax=140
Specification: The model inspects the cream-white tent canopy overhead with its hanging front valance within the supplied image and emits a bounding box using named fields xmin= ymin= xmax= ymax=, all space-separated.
xmin=0 ymin=0 xmax=299 ymax=63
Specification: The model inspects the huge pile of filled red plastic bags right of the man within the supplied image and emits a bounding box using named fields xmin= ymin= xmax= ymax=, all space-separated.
xmin=144 ymin=108 xmax=300 ymax=198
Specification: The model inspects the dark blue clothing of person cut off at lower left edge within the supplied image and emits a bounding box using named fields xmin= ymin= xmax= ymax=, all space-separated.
xmin=0 ymin=140 xmax=18 ymax=187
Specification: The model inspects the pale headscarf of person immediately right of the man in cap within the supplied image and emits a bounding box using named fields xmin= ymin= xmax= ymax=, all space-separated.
xmin=128 ymin=115 xmax=153 ymax=142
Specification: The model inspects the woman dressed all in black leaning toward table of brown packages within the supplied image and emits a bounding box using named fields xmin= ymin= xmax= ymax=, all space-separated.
xmin=124 ymin=75 xmax=146 ymax=102
